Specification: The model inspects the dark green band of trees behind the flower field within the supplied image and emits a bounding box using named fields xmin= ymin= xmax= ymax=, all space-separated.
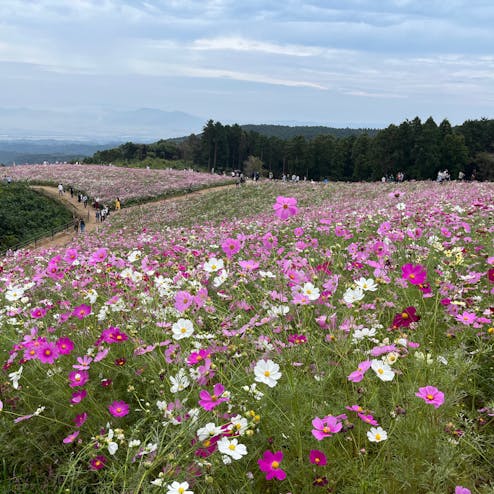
xmin=85 ymin=117 xmax=494 ymax=181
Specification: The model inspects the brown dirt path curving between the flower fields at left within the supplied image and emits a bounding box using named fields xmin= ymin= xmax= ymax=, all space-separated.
xmin=26 ymin=184 xmax=239 ymax=249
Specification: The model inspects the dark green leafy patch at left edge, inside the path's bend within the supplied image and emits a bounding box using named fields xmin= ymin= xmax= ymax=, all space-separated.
xmin=0 ymin=182 xmax=72 ymax=252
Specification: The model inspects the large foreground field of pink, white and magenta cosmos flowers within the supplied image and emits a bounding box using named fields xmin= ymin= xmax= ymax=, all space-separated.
xmin=0 ymin=169 xmax=494 ymax=494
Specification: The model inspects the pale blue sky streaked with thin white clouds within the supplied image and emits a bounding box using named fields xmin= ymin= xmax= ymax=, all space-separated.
xmin=0 ymin=0 xmax=494 ymax=135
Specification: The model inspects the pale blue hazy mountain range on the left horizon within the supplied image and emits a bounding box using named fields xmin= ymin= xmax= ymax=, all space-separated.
xmin=0 ymin=108 xmax=205 ymax=142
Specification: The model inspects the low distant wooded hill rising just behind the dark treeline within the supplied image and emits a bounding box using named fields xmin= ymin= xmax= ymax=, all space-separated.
xmin=241 ymin=124 xmax=379 ymax=139
